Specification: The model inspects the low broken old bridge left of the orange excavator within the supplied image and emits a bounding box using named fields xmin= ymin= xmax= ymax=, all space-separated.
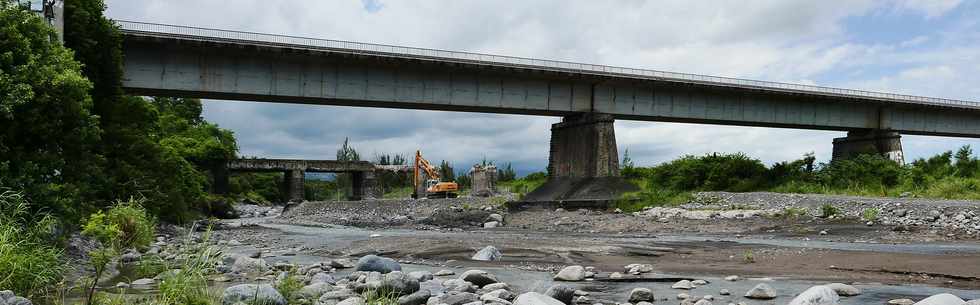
xmin=215 ymin=159 xmax=387 ymax=201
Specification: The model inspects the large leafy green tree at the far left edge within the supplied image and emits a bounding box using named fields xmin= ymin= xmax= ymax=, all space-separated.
xmin=0 ymin=0 xmax=104 ymax=218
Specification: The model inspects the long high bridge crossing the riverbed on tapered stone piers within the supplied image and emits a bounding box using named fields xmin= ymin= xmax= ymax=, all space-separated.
xmin=118 ymin=21 xmax=980 ymax=200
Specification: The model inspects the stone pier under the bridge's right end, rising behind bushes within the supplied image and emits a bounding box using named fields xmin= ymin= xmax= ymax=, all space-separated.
xmin=833 ymin=129 xmax=905 ymax=164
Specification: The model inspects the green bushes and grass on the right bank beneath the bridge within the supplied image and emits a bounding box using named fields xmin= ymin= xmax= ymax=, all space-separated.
xmin=617 ymin=146 xmax=980 ymax=210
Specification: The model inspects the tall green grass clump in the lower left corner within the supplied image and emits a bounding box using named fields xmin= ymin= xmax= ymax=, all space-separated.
xmin=0 ymin=191 xmax=66 ymax=298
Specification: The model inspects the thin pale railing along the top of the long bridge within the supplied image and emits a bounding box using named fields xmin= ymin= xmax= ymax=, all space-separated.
xmin=116 ymin=20 xmax=980 ymax=109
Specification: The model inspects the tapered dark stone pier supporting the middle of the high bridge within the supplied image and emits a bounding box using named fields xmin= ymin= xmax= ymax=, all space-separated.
xmin=548 ymin=113 xmax=619 ymax=179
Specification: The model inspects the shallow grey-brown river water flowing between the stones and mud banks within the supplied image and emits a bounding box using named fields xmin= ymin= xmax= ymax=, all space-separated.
xmin=241 ymin=223 xmax=980 ymax=304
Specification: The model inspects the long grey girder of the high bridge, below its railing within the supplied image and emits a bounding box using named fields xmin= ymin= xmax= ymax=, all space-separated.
xmin=123 ymin=35 xmax=980 ymax=137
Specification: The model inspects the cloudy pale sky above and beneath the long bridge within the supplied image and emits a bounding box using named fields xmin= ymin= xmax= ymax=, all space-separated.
xmin=107 ymin=0 xmax=980 ymax=173
